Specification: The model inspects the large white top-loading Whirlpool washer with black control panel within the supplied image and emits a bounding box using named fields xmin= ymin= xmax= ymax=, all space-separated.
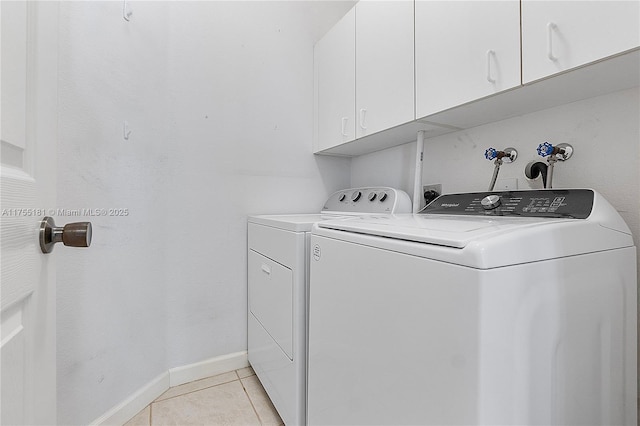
xmin=308 ymin=189 xmax=637 ymax=425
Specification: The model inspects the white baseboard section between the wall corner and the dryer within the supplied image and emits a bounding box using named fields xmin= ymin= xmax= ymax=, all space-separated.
xmin=169 ymin=351 xmax=249 ymax=386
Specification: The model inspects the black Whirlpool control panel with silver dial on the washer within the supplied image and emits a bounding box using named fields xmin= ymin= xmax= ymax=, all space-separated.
xmin=420 ymin=189 xmax=594 ymax=219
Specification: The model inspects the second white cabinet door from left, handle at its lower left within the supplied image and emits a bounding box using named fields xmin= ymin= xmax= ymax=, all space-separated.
xmin=355 ymin=0 xmax=415 ymax=138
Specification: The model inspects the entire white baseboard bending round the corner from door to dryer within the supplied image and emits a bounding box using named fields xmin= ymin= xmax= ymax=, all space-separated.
xmin=91 ymin=351 xmax=249 ymax=425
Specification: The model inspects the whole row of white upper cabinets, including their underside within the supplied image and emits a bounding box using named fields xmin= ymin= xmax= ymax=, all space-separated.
xmin=314 ymin=0 xmax=640 ymax=155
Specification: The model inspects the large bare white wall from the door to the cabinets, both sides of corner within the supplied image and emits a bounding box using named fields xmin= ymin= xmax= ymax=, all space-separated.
xmin=56 ymin=2 xmax=350 ymax=424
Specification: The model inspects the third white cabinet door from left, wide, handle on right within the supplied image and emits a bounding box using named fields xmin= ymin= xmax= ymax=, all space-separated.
xmin=416 ymin=0 xmax=520 ymax=118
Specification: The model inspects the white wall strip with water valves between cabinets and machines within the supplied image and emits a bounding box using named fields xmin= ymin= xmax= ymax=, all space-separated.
xmin=351 ymin=88 xmax=640 ymax=392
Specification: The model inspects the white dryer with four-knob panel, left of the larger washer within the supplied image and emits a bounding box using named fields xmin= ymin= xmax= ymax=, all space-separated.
xmin=248 ymin=187 xmax=411 ymax=425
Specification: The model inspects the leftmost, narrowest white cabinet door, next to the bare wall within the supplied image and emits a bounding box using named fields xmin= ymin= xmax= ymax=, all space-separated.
xmin=314 ymin=9 xmax=356 ymax=152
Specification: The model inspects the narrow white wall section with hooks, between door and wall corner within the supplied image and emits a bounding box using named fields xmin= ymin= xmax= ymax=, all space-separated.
xmin=55 ymin=2 xmax=170 ymax=424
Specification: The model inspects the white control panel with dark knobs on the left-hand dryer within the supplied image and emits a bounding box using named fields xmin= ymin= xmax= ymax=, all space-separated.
xmin=322 ymin=187 xmax=411 ymax=213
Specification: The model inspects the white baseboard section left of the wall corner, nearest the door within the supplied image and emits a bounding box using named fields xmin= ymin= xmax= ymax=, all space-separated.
xmin=91 ymin=371 xmax=169 ymax=425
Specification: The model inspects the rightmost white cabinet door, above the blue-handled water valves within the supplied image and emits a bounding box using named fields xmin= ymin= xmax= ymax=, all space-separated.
xmin=522 ymin=0 xmax=640 ymax=83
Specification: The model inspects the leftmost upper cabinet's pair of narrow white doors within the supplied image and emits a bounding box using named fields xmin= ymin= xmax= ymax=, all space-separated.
xmin=314 ymin=0 xmax=415 ymax=152
